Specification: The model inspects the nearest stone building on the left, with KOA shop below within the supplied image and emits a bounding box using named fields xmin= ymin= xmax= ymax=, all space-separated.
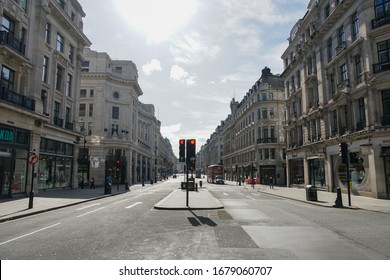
xmin=0 ymin=0 xmax=90 ymax=197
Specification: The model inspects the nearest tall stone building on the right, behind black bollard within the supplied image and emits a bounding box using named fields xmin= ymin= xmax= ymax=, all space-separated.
xmin=282 ymin=0 xmax=390 ymax=198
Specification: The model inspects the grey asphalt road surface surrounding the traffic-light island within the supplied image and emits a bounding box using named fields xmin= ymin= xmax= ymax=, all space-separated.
xmin=0 ymin=178 xmax=390 ymax=260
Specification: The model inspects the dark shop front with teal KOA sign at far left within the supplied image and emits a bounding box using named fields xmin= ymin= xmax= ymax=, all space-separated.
xmin=0 ymin=124 xmax=30 ymax=197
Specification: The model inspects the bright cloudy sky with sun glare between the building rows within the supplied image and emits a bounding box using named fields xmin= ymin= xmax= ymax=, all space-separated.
xmin=79 ymin=0 xmax=309 ymax=156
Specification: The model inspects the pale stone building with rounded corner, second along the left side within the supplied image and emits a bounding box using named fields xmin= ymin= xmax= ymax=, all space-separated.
xmin=78 ymin=48 xmax=173 ymax=185
